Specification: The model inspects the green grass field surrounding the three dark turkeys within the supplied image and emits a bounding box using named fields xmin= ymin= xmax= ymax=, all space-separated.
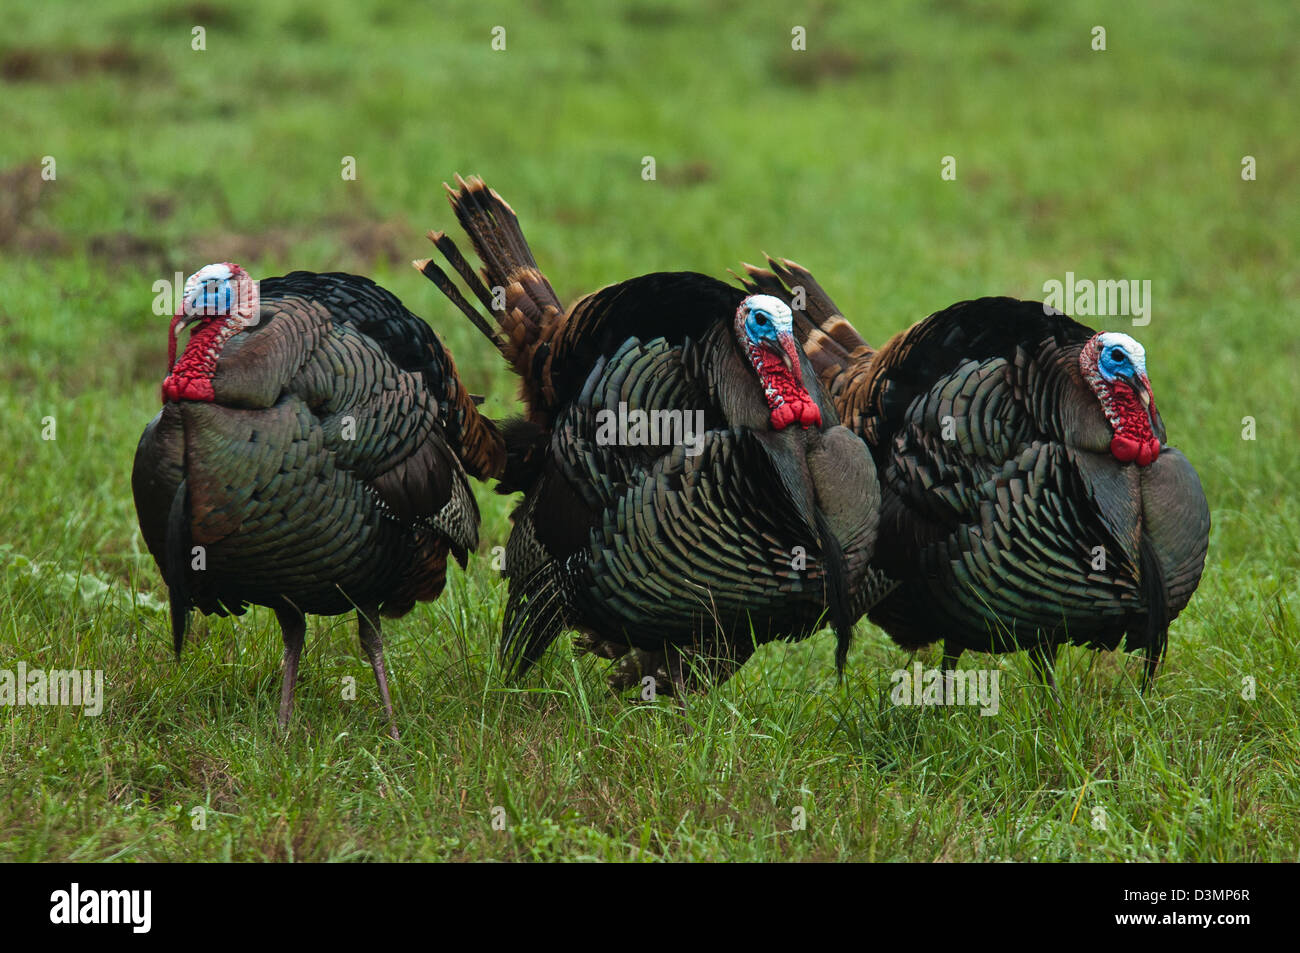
xmin=0 ymin=0 xmax=1300 ymax=861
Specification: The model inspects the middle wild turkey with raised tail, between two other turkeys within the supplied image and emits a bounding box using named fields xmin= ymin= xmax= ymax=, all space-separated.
xmin=416 ymin=178 xmax=879 ymax=694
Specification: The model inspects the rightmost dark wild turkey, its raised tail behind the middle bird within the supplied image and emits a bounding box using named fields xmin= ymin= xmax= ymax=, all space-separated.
xmin=746 ymin=259 xmax=1210 ymax=688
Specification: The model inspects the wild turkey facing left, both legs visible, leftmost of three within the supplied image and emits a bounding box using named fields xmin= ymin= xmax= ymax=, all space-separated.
xmin=131 ymin=263 xmax=504 ymax=737
